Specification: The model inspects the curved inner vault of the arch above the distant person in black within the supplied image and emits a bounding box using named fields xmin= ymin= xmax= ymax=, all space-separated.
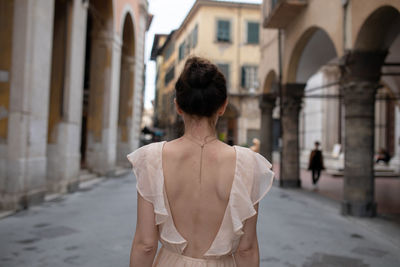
xmin=286 ymin=26 xmax=338 ymax=83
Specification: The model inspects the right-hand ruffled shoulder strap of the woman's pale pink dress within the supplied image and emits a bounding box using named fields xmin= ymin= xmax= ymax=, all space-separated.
xmin=205 ymin=146 xmax=274 ymax=257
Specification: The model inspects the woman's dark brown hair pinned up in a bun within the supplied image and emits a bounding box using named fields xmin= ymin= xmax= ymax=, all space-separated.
xmin=175 ymin=57 xmax=227 ymax=117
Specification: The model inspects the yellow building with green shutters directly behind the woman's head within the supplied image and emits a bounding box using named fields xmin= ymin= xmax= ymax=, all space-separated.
xmin=152 ymin=0 xmax=261 ymax=145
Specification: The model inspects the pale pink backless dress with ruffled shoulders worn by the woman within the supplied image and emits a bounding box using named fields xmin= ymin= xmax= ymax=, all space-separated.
xmin=127 ymin=142 xmax=274 ymax=267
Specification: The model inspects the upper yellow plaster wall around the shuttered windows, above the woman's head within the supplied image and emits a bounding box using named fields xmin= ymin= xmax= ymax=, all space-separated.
xmin=176 ymin=6 xmax=261 ymax=94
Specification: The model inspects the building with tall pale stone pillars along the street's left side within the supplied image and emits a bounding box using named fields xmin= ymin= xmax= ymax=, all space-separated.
xmin=0 ymin=0 xmax=151 ymax=209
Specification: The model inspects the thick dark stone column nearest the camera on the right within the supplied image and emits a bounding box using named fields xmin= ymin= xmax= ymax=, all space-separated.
xmin=342 ymin=52 xmax=386 ymax=217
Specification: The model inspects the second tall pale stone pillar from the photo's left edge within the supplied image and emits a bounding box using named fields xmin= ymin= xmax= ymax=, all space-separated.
xmin=47 ymin=0 xmax=87 ymax=192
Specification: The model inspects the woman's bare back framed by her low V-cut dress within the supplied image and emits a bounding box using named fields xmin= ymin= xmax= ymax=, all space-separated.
xmin=162 ymin=137 xmax=236 ymax=258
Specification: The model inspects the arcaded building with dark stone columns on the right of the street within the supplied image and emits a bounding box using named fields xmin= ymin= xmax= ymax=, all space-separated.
xmin=260 ymin=0 xmax=400 ymax=216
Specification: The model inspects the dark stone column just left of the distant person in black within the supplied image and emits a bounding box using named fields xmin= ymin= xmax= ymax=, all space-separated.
xmin=279 ymin=84 xmax=305 ymax=187
